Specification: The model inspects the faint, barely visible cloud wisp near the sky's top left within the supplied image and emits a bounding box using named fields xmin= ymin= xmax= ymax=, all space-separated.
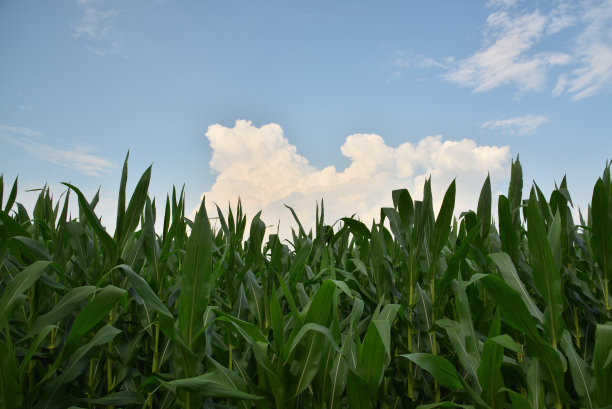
xmin=70 ymin=0 xmax=124 ymax=56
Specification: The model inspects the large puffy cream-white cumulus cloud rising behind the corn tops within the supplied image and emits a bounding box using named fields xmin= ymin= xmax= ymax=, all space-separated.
xmin=197 ymin=120 xmax=510 ymax=237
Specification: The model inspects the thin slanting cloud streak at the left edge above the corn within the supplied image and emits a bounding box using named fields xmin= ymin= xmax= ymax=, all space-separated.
xmin=0 ymin=125 xmax=116 ymax=176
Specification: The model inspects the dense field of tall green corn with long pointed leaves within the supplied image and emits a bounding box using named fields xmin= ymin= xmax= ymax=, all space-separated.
xmin=0 ymin=155 xmax=612 ymax=409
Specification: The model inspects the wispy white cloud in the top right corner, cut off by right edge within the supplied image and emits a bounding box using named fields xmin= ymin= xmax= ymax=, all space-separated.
xmin=553 ymin=0 xmax=612 ymax=100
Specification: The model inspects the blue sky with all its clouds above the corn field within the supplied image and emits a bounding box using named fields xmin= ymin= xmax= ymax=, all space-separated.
xmin=0 ymin=0 xmax=612 ymax=234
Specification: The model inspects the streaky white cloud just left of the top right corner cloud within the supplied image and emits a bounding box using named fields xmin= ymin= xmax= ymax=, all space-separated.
xmin=444 ymin=10 xmax=570 ymax=92
